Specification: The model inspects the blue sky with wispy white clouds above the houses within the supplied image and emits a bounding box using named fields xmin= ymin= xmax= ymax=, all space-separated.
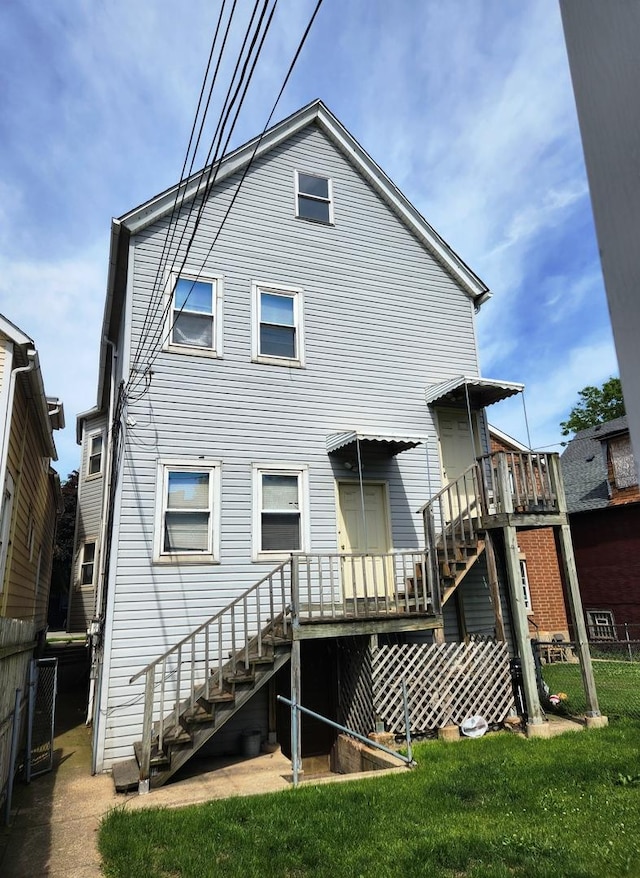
xmin=0 ymin=0 xmax=617 ymax=477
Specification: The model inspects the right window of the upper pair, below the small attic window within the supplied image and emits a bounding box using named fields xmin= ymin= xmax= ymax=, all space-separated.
xmin=252 ymin=283 xmax=304 ymax=366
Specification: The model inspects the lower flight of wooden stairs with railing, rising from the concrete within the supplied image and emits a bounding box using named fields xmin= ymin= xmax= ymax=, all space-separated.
xmin=112 ymin=564 xmax=292 ymax=792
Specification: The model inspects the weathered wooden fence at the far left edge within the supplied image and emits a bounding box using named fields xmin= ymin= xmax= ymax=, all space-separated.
xmin=0 ymin=618 xmax=36 ymax=806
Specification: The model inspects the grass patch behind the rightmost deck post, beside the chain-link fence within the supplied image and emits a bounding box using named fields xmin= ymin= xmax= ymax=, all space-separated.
xmin=542 ymin=659 xmax=640 ymax=720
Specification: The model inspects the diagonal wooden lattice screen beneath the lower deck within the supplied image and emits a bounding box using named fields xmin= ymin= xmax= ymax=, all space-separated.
xmin=341 ymin=640 xmax=515 ymax=735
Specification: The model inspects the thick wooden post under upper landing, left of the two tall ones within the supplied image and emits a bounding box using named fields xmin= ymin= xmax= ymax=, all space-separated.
xmin=502 ymin=526 xmax=545 ymax=735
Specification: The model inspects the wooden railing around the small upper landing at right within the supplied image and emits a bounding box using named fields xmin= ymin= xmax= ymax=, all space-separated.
xmin=478 ymin=451 xmax=564 ymax=515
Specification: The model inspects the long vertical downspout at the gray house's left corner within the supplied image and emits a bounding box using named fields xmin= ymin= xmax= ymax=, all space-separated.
xmin=85 ymin=336 xmax=118 ymax=744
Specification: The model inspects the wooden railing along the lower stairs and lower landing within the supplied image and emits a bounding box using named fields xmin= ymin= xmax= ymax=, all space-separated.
xmin=129 ymin=550 xmax=434 ymax=780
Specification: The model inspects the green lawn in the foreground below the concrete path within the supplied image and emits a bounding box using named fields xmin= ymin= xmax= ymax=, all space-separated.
xmin=99 ymin=721 xmax=640 ymax=878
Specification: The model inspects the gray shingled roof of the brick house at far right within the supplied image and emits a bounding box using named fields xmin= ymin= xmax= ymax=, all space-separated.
xmin=560 ymin=415 xmax=628 ymax=512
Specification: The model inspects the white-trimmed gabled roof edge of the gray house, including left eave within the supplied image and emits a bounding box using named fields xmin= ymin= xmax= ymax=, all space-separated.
xmin=98 ymin=100 xmax=491 ymax=418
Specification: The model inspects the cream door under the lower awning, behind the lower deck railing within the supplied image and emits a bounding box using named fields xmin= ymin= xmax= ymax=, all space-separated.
xmin=338 ymin=482 xmax=393 ymax=597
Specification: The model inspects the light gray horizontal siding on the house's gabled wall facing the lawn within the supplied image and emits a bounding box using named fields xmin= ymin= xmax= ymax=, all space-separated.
xmin=101 ymin=127 xmax=478 ymax=767
